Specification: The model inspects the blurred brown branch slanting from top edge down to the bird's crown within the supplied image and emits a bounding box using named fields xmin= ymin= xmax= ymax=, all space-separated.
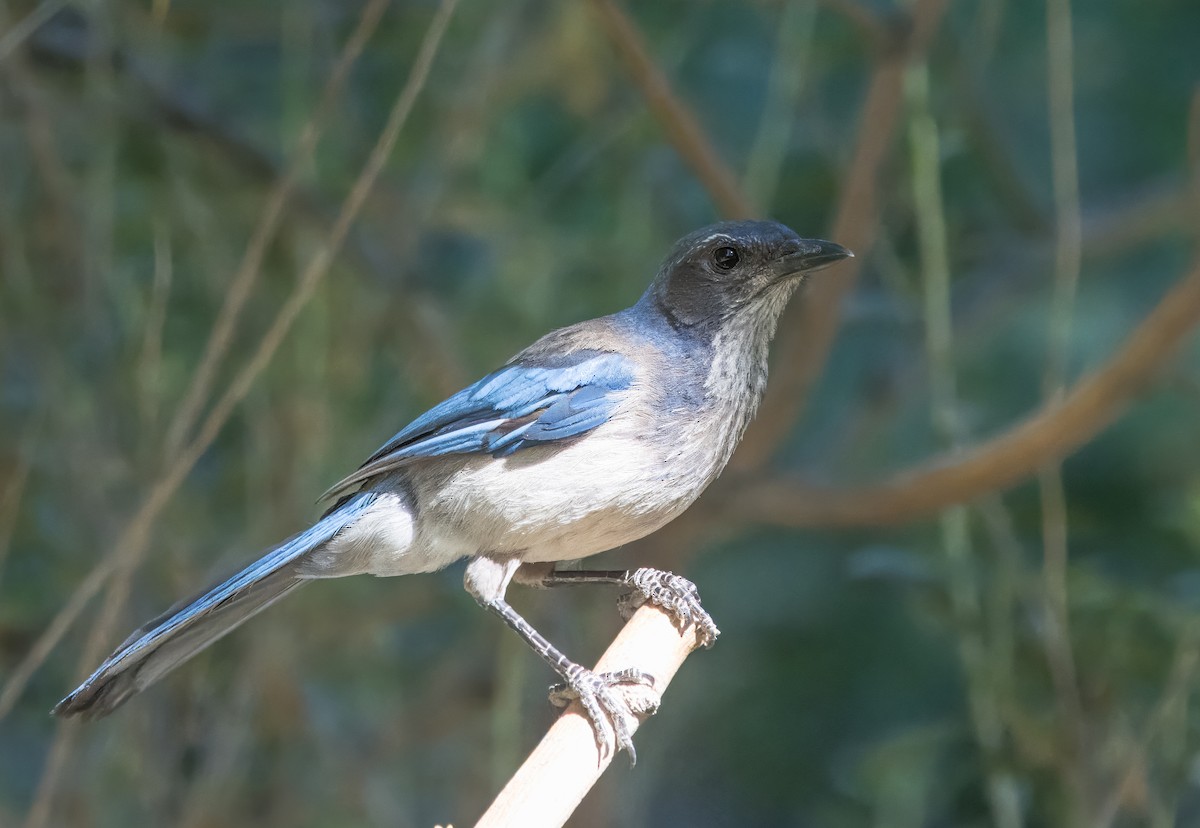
xmin=592 ymin=0 xmax=758 ymax=218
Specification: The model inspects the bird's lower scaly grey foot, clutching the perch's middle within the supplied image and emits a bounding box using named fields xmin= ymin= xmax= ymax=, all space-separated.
xmin=550 ymin=665 xmax=659 ymax=767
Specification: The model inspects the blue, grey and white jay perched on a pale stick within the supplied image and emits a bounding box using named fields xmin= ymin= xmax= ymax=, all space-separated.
xmin=53 ymin=221 xmax=853 ymax=761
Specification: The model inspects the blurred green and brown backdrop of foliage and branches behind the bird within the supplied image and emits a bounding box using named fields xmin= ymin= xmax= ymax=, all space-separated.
xmin=0 ymin=0 xmax=1200 ymax=828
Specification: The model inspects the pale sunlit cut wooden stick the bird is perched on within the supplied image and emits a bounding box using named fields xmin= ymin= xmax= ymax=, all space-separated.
xmin=475 ymin=604 xmax=697 ymax=828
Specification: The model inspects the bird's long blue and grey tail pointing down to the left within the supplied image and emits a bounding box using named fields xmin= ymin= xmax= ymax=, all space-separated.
xmin=53 ymin=493 xmax=374 ymax=719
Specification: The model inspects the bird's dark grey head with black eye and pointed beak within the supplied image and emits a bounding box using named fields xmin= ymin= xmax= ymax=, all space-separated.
xmin=643 ymin=221 xmax=853 ymax=328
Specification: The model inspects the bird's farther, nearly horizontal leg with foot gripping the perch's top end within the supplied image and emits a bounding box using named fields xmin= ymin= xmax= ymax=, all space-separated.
xmin=516 ymin=565 xmax=721 ymax=647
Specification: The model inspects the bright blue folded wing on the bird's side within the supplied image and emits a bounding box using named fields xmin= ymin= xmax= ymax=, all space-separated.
xmin=325 ymin=350 xmax=634 ymax=497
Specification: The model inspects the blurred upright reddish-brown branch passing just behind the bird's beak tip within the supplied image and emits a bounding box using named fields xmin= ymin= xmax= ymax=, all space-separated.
xmin=731 ymin=0 xmax=946 ymax=472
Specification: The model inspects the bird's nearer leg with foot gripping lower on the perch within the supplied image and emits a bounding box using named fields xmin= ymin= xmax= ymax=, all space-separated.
xmin=464 ymin=558 xmax=654 ymax=764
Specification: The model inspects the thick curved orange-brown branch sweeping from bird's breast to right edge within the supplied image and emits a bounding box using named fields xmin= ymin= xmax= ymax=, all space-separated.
xmin=706 ymin=249 xmax=1200 ymax=527
